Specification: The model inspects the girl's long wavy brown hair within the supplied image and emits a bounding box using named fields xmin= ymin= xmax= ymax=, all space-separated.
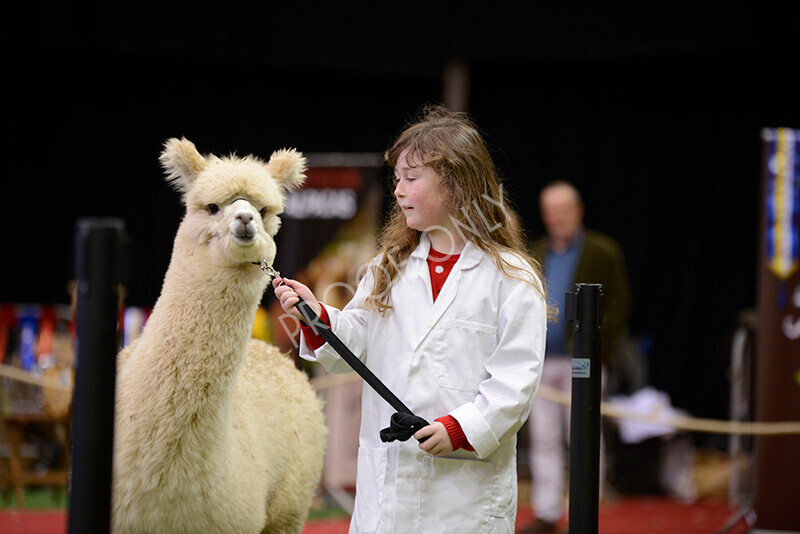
xmin=365 ymin=105 xmax=544 ymax=313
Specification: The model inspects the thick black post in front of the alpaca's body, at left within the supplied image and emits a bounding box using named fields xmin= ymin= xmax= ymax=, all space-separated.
xmin=69 ymin=219 xmax=125 ymax=534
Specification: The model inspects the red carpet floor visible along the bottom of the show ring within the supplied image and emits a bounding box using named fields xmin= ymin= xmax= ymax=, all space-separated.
xmin=0 ymin=497 xmax=747 ymax=534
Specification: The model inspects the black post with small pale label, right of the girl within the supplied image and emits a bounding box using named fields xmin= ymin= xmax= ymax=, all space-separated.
xmin=565 ymin=284 xmax=603 ymax=534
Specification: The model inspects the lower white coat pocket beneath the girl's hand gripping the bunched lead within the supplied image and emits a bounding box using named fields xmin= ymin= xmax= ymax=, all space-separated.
xmin=419 ymin=455 xmax=510 ymax=532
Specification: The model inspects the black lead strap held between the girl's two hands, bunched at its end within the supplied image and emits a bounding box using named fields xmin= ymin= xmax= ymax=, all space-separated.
xmin=295 ymin=297 xmax=428 ymax=443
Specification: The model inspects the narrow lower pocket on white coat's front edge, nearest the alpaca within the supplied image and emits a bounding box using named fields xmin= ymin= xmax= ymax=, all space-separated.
xmin=353 ymin=447 xmax=387 ymax=534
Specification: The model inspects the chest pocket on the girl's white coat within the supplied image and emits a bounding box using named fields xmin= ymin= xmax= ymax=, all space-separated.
xmin=431 ymin=319 xmax=497 ymax=393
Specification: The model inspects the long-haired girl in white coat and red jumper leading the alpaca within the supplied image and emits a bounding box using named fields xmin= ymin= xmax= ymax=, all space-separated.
xmin=273 ymin=107 xmax=547 ymax=533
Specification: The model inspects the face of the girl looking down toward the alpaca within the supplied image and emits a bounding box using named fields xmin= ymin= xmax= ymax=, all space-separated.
xmin=394 ymin=149 xmax=452 ymax=233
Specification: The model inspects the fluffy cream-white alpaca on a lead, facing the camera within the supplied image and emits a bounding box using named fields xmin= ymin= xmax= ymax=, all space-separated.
xmin=112 ymin=139 xmax=326 ymax=534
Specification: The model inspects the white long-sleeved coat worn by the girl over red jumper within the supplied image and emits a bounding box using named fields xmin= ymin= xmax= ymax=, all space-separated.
xmin=300 ymin=239 xmax=546 ymax=534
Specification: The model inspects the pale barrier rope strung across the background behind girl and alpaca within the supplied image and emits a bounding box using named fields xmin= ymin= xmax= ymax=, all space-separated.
xmin=6 ymin=364 xmax=800 ymax=436
